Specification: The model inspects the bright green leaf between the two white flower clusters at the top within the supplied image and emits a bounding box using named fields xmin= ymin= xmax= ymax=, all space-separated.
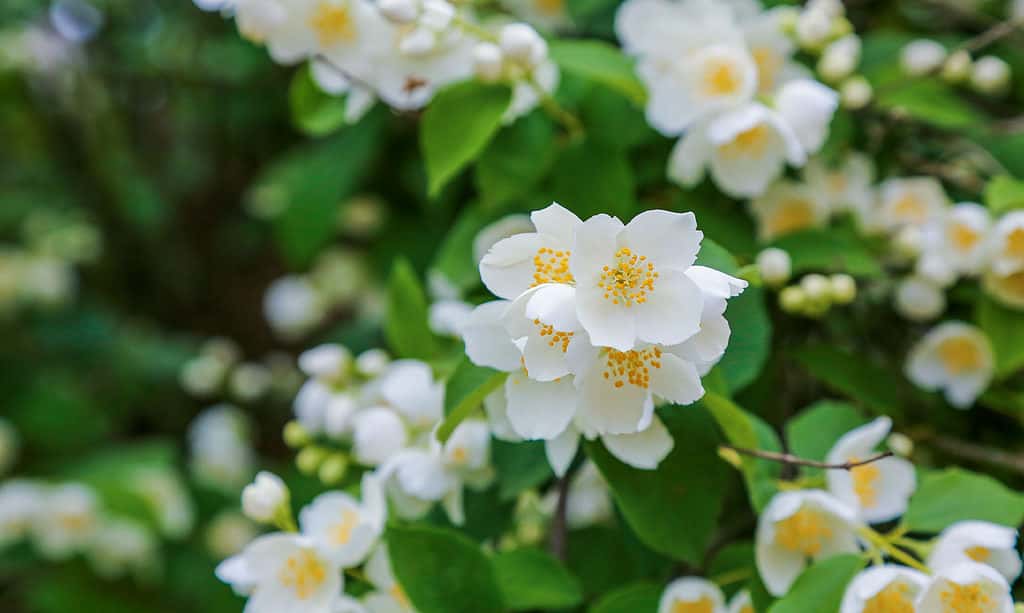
xmin=551 ymin=40 xmax=647 ymax=104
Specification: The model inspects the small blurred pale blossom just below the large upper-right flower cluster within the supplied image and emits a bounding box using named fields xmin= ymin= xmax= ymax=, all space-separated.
xmin=803 ymin=152 xmax=874 ymax=218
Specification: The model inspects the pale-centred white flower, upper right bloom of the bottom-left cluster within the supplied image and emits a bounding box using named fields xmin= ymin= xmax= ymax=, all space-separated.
xmin=299 ymin=473 xmax=387 ymax=568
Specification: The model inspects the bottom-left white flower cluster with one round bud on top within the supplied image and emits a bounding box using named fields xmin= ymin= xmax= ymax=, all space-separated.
xmin=217 ymin=473 xmax=399 ymax=613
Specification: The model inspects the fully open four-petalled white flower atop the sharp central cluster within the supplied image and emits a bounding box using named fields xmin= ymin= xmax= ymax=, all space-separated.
xmin=569 ymin=211 xmax=703 ymax=353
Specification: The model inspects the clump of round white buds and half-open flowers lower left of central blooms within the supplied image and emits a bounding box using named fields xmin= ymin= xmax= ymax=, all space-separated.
xmin=286 ymin=345 xmax=494 ymax=523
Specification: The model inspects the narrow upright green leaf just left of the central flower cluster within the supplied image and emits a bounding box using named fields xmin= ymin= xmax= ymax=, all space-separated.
xmin=384 ymin=258 xmax=438 ymax=359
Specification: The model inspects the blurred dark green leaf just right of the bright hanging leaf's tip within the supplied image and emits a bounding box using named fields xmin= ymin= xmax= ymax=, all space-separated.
xmin=475 ymin=112 xmax=557 ymax=207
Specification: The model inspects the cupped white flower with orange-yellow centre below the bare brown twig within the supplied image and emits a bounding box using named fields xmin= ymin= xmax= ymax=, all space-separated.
xmin=755 ymin=489 xmax=860 ymax=596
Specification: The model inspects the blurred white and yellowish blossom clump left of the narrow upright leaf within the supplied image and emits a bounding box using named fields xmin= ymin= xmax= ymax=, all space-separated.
xmin=263 ymin=248 xmax=383 ymax=341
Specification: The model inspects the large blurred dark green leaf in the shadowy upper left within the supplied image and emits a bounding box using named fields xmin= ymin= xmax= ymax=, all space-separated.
xmin=256 ymin=108 xmax=383 ymax=268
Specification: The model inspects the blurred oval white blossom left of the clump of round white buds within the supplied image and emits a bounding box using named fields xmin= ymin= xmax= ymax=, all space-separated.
xmin=188 ymin=404 xmax=256 ymax=493
